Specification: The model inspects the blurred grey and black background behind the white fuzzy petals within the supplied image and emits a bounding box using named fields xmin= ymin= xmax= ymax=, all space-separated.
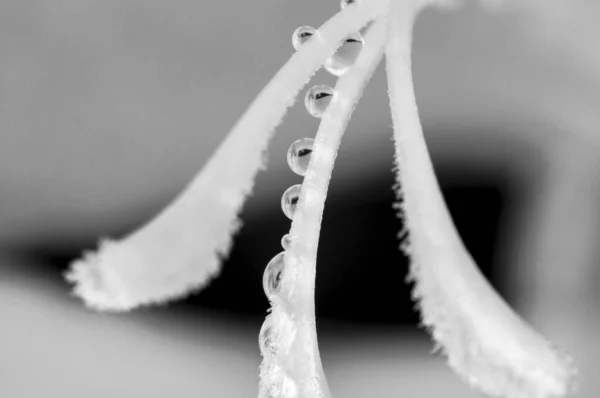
xmin=0 ymin=0 xmax=600 ymax=398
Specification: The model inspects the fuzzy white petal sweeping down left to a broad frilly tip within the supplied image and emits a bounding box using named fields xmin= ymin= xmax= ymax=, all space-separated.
xmin=66 ymin=0 xmax=387 ymax=311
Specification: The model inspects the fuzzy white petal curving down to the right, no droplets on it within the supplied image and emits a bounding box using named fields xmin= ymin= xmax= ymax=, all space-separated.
xmin=386 ymin=0 xmax=573 ymax=398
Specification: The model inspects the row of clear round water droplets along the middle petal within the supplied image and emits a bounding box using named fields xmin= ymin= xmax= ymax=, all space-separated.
xmin=259 ymin=0 xmax=364 ymax=398
